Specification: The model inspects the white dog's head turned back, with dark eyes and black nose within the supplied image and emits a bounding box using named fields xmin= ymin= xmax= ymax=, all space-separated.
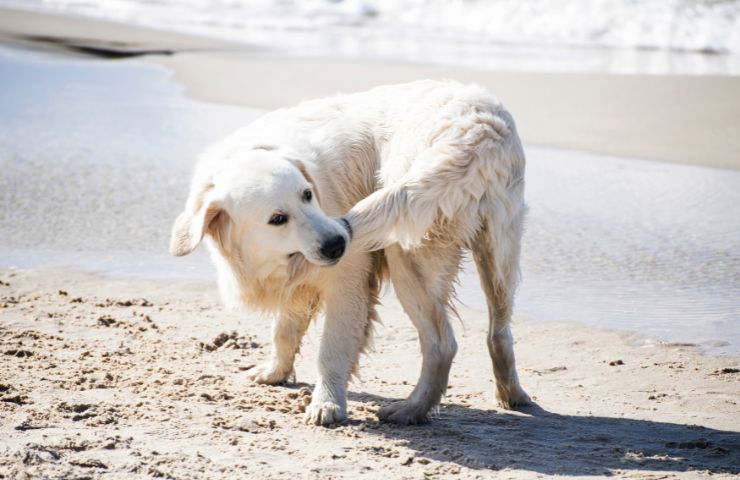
xmin=170 ymin=149 xmax=349 ymax=277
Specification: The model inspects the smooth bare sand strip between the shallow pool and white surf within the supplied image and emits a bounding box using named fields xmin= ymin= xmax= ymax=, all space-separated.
xmin=0 ymin=8 xmax=740 ymax=169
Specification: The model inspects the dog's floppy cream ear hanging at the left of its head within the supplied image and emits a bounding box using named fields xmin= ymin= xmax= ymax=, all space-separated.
xmin=170 ymin=189 xmax=223 ymax=257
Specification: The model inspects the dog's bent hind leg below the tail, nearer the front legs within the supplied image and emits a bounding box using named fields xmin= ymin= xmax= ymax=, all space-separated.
xmin=378 ymin=245 xmax=461 ymax=425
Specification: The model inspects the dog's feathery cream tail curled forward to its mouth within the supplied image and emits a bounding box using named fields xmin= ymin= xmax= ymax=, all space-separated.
xmin=344 ymin=108 xmax=524 ymax=250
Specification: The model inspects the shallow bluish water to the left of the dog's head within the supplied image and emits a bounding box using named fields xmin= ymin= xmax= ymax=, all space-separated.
xmin=0 ymin=45 xmax=261 ymax=277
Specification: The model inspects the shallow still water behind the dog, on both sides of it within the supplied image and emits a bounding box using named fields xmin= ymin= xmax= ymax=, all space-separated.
xmin=0 ymin=49 xmax=740 ymax=355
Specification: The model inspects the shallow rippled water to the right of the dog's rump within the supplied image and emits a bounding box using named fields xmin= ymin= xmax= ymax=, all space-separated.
xmin=460 ymin=147 xmax=740 ymax=353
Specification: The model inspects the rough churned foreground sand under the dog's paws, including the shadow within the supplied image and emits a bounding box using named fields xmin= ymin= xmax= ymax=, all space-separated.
xmin=0 ymin=270 xmax=740 ymax=479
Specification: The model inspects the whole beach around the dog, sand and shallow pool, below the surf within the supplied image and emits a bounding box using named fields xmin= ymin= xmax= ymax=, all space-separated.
xmin=0 ymin=4 xmax=740 ymax=479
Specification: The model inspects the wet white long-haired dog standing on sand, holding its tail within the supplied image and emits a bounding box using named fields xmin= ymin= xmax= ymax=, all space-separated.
xmin=170 ymin=81 xmax=529 ymax=425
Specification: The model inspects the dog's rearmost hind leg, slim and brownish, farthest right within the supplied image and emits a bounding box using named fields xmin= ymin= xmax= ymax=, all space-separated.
xmin=471 ymin=218 xmax=530 ymax=408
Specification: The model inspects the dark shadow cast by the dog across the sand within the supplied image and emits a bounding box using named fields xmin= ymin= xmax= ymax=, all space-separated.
xmin=322 ymin=392 xmax=740 ymax=475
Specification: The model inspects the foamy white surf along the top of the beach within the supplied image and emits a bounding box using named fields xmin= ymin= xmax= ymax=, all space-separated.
xmin=5 ymin=0 xmax=740 ymax=54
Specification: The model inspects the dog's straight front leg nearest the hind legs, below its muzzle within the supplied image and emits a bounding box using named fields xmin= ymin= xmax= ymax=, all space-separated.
xmin=306 ymin=279 xmax=369 ymax=425
